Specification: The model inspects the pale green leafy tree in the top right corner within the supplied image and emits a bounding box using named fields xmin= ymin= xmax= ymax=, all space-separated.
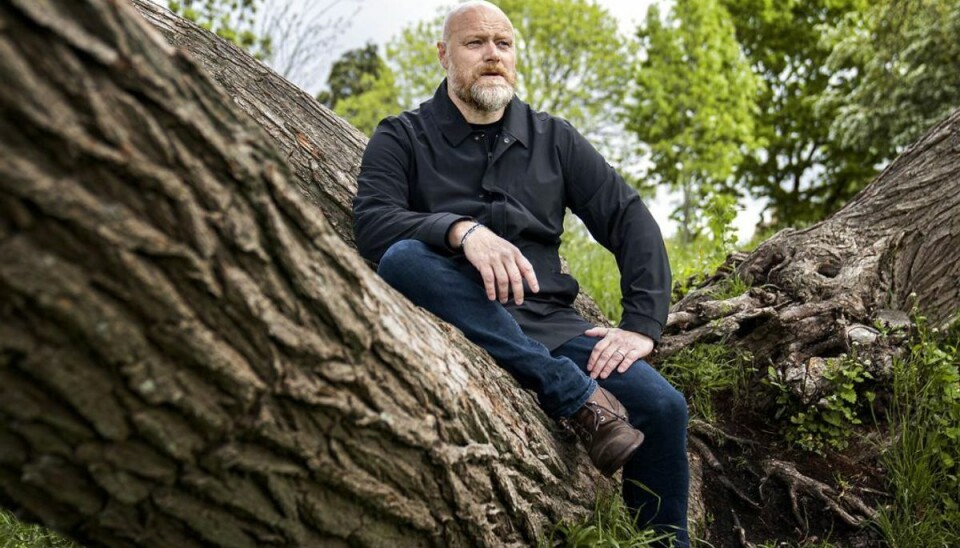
xmin=822 ymin=0 xmax=960 ymax=160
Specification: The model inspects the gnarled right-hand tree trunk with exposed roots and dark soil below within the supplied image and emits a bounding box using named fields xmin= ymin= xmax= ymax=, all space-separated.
xmin=658 ymin=111 xmax=960 ymax=546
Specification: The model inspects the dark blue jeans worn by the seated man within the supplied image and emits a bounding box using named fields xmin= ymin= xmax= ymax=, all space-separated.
xmin=377 ymin=240 xmax=690 ymax=547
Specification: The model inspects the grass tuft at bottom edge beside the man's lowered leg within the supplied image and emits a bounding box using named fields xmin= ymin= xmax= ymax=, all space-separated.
xmin=538 ymin=493 xmax=673 ymax=548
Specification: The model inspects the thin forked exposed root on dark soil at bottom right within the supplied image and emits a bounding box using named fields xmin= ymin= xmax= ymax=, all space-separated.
xmin=762 ymin=459 xmax=877 ymax=527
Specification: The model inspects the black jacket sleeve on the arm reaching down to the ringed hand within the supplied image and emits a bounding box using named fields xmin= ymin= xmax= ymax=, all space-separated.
xmin=561 ymin=125 xmax=671 ymax=342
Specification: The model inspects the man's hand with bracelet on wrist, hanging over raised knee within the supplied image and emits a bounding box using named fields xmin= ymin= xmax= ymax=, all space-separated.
xmin=448 ymin=221 xmax=540 ymax=305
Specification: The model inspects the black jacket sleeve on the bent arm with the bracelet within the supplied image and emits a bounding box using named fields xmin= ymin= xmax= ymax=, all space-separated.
xmin=353 ymin=117 xmax=469 ymax=263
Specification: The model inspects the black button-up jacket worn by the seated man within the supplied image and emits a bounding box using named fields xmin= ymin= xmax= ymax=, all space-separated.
xmin=353 ymin=81 xmax=670 ymax=349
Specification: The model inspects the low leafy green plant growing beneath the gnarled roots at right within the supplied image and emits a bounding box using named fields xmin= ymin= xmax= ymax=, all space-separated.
xmin=765 ymin=354 xmax=875 ymax=455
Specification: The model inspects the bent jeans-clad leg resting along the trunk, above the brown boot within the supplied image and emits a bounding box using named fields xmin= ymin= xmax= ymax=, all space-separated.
xmin=377 ymin=240 xmax=596 ymax=418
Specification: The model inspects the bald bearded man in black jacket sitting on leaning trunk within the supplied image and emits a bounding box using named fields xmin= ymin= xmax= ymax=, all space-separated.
xmin=354 ymin=2 xmax=689 ymax=546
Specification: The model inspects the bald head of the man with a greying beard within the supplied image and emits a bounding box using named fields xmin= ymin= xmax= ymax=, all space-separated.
xmin=437 ymin=1 xmax=517 ymax=113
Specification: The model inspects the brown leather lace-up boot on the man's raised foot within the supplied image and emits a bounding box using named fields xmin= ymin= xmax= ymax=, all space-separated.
xmin=567 ymin=386 xmax=643 ymax=476
